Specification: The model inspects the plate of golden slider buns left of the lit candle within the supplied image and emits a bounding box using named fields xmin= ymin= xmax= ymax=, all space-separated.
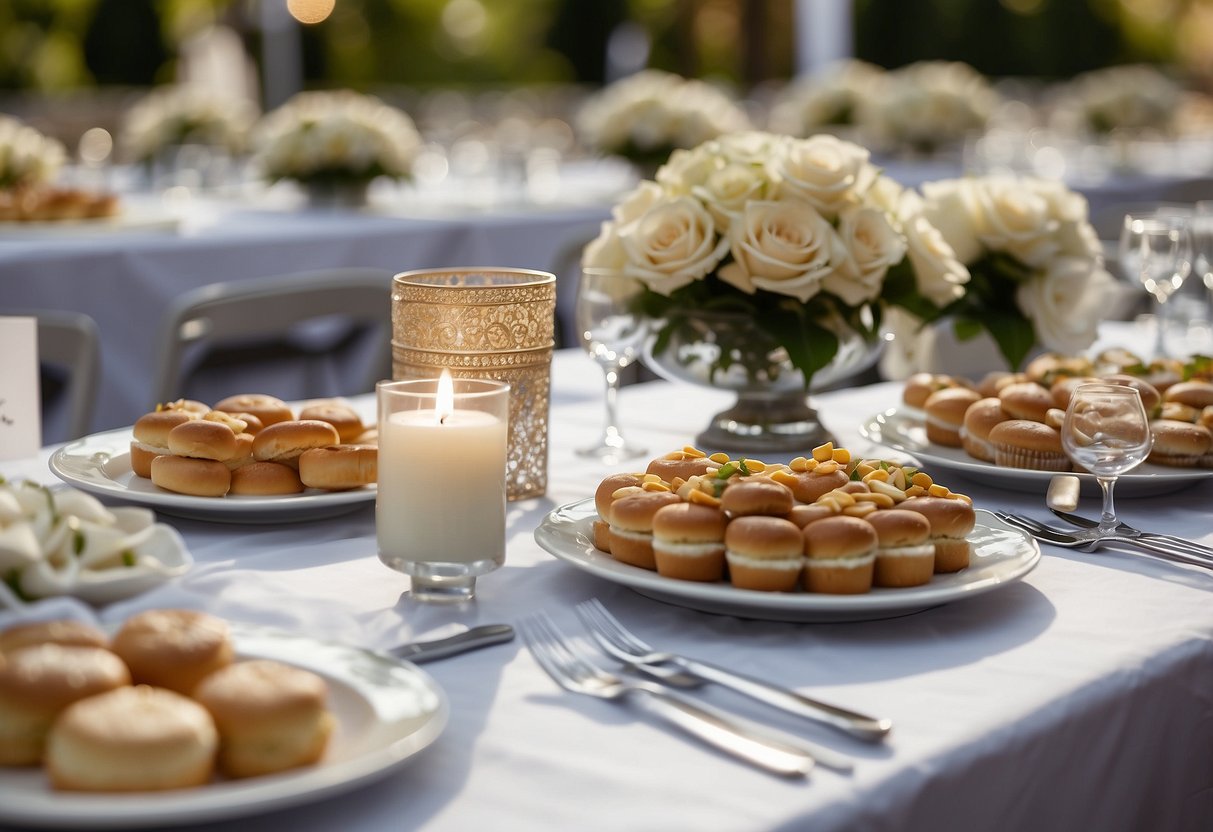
xmin=50 ymin=393 xmax=378 ymax=523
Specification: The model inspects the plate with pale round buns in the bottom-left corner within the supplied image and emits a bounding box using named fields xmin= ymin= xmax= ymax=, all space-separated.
xmin=0 ymin=609 xmax=449 ymax=830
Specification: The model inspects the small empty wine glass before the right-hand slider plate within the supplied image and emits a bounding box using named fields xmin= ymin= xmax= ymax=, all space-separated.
xmin=1061 ymin=382 xmax=1154 ymax=538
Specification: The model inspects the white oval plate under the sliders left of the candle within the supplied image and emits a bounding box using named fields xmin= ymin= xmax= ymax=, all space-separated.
xmin=51 ymin=428 xmax=376 ymax=523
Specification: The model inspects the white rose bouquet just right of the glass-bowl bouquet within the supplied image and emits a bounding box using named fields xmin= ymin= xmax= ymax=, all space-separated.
xmin=899 ymin=176 xmax=1116 ymax=369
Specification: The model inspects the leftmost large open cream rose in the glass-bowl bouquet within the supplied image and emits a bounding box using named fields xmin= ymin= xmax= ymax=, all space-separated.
xmin=619 ymin=196 xmax=729 ymax=295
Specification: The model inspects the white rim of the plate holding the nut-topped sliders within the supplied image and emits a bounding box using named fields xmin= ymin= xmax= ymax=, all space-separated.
xmin=535 ymin=497 xmax=1041 ymax=621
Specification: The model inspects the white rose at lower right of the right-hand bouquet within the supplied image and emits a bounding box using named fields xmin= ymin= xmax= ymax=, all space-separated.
xmin=1015 ymin=257 xmax=1116 ymax=355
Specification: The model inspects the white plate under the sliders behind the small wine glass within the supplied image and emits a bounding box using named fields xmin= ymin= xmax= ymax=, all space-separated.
xmin=859 ymin=408 xmax=1213 ymax=497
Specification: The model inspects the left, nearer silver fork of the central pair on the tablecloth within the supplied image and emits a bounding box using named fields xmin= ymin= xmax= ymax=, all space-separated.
xmin=519 ymin=612 xmax=814 ymax=777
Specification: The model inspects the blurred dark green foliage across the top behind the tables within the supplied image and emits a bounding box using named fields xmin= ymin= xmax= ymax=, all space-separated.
xmin=0 ymin=0 xmax=1213 ymax=92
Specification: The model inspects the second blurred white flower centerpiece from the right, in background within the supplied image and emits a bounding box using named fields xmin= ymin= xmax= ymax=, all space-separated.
xmin=859 ymin=61 xmax=998 ymax=154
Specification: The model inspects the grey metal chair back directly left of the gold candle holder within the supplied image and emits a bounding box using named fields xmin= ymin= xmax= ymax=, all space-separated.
xmin=149 ymin=268 xmax=392 ymax=406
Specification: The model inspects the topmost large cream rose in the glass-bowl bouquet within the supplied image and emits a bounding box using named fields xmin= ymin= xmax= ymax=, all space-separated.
xmin=776 ymin=135 xmax=879 ymax=216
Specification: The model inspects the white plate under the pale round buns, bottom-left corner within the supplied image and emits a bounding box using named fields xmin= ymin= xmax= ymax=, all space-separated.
xmin=0 ymin=625 xmax=449 ymax=830
